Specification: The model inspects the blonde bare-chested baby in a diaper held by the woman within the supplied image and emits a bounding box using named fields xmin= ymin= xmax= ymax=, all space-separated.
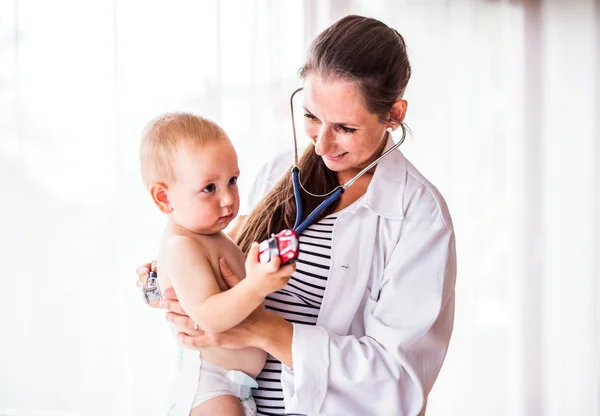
xmin=140 ymin=113 xmax=294 ymax=416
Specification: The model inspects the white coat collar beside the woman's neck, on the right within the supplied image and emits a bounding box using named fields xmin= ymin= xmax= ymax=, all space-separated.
xmin=361 ymin=135 xmax=407 ymax=220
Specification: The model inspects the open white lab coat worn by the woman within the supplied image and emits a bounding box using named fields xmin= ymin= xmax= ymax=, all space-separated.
xmin=243 ymin=140 xmax=456 ymax=416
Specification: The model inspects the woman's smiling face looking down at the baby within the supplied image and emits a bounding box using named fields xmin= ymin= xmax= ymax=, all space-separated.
xmin=304 ymin=74 xmax=388 ymax=177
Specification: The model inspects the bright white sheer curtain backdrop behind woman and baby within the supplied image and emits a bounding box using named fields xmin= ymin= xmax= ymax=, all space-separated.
xmin=0 ymin=0 xmax=600 ymax=416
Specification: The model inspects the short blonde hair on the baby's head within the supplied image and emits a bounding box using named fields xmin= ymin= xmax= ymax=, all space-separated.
xmin=140 ymin=113 xmax=227 ymax=188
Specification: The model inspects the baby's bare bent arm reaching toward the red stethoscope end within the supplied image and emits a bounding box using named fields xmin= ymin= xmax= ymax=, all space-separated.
xmin=160 ymin=237 xmax=293 ymax=333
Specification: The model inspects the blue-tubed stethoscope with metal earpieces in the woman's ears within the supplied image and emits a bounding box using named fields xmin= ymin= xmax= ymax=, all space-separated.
xmin=290 ymin=88 xmax=406 ymax=235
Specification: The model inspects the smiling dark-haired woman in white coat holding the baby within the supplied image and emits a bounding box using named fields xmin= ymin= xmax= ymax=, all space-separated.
xmin=138 ymin=16 xmax=456 ymax=415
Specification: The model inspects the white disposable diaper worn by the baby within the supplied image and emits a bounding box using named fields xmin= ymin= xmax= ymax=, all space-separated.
xmin=167 ymin=350 xmax=258 ymax=416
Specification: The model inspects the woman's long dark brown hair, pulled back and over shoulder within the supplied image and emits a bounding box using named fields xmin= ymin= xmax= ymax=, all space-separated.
xmin=237 ymin=15 xmax=411 ymax=253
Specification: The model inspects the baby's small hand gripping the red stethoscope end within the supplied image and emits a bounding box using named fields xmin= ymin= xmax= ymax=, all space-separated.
xmin=246 ymin=242 xmax=296 ymax=297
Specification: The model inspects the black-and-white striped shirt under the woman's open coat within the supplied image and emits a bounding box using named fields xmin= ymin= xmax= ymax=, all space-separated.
xmin=253 ymin=213 xmax=339 ymax=416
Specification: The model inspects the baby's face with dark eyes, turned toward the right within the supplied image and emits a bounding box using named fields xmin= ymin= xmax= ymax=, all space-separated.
xmin=168 ymin=139 xmax=240 ymax=234
